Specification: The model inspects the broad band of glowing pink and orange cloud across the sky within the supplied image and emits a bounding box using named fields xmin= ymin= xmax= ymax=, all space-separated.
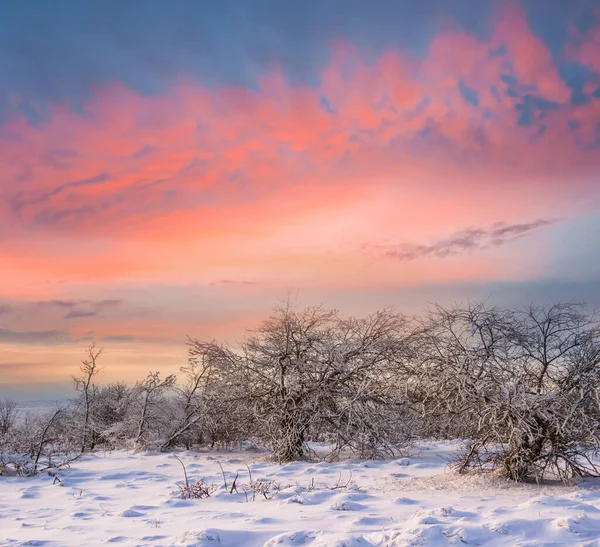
xmin=0 ymin=4 xmax=600 ymax=300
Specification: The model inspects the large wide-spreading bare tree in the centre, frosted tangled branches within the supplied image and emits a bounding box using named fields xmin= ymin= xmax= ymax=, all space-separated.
xmin=192 ymin=302 xmax=406 ymax=461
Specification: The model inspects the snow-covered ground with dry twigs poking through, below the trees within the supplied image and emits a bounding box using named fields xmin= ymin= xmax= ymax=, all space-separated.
xmin=0 ymin=443 xmax=600 ymax=547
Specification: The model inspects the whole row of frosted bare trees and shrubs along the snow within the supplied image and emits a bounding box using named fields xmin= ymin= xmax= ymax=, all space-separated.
xmin=0 ymin=302 xmax=600 ymax=482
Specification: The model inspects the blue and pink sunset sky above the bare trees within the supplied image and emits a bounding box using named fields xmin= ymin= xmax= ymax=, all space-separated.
xmin=0 ymin=0 xmax=600 ymax=399
